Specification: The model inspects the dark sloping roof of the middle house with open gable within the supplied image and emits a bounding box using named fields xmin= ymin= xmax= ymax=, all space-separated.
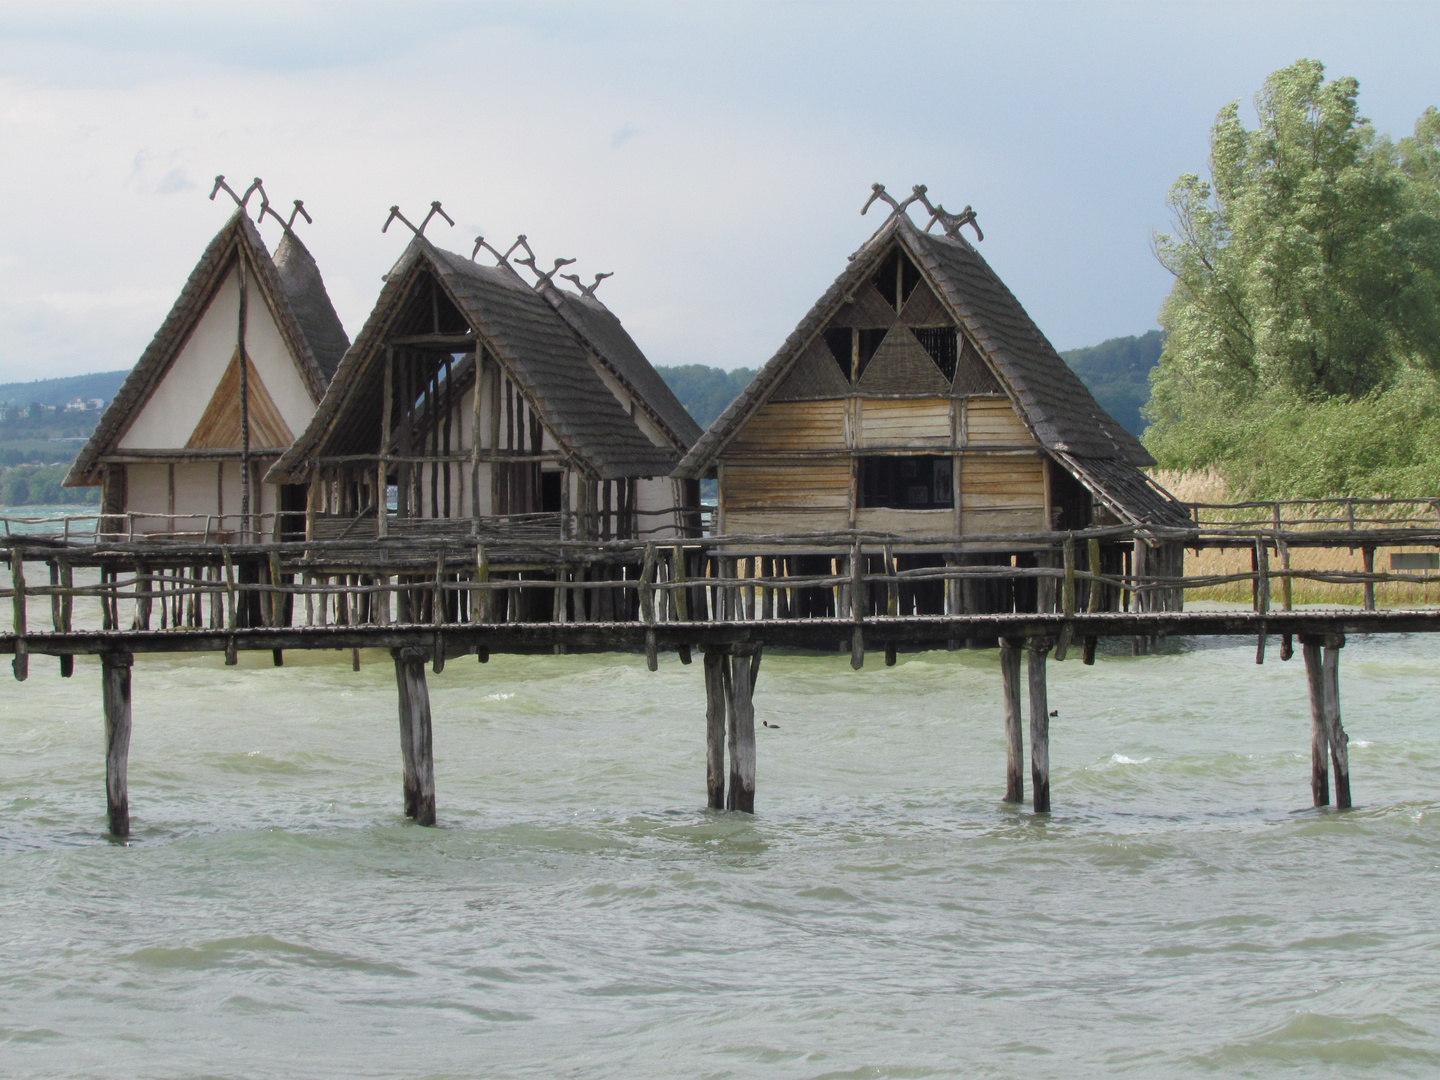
xmin=271 ymin=243 xmax=698 ymax=481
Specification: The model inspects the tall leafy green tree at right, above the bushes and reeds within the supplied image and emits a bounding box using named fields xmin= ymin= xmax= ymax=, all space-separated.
xmin=1146 ymin=60 xmax=1440 ymax=480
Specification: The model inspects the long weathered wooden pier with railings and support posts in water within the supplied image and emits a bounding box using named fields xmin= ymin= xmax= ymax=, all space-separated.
xmin=0 ymin=500 xmax=1440 ymax=837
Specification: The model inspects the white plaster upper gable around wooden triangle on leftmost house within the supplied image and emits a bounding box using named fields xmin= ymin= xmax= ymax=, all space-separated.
xmin=120 ymin=271 xmax=315 ymax=449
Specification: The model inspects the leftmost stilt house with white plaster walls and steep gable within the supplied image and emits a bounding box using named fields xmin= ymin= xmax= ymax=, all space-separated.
xmin=65 ymin=207 xmax=350 ymax=541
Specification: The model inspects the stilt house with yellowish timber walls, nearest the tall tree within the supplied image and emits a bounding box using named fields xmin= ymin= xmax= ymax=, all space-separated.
xmin=677 ymin=189 xmax=1189 ymax=613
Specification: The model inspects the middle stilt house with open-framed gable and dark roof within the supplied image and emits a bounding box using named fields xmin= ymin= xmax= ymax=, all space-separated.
xmin=271 ymin=233 xmax=700 ymax=539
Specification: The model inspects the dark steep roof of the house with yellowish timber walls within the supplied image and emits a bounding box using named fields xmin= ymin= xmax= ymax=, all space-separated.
xmin=677 ymin=213 xmax=1184 ymax=520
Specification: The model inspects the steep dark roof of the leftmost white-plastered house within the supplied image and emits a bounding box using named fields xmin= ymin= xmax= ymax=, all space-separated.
xmin=65 ymin=209 xmax=350 ymax=487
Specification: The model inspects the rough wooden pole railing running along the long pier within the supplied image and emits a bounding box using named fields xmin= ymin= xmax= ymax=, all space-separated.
xmin=0 ymin=514 xmax=1440 ymax=665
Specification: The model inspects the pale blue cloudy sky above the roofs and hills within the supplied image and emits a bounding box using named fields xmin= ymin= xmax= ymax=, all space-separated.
xmin=0 ymin=0 xmax=1440 ymax=382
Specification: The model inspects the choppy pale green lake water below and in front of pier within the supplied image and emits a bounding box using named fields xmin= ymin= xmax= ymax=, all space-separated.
xmin=0 ymin=636 xmax=1440 ymax=1080
